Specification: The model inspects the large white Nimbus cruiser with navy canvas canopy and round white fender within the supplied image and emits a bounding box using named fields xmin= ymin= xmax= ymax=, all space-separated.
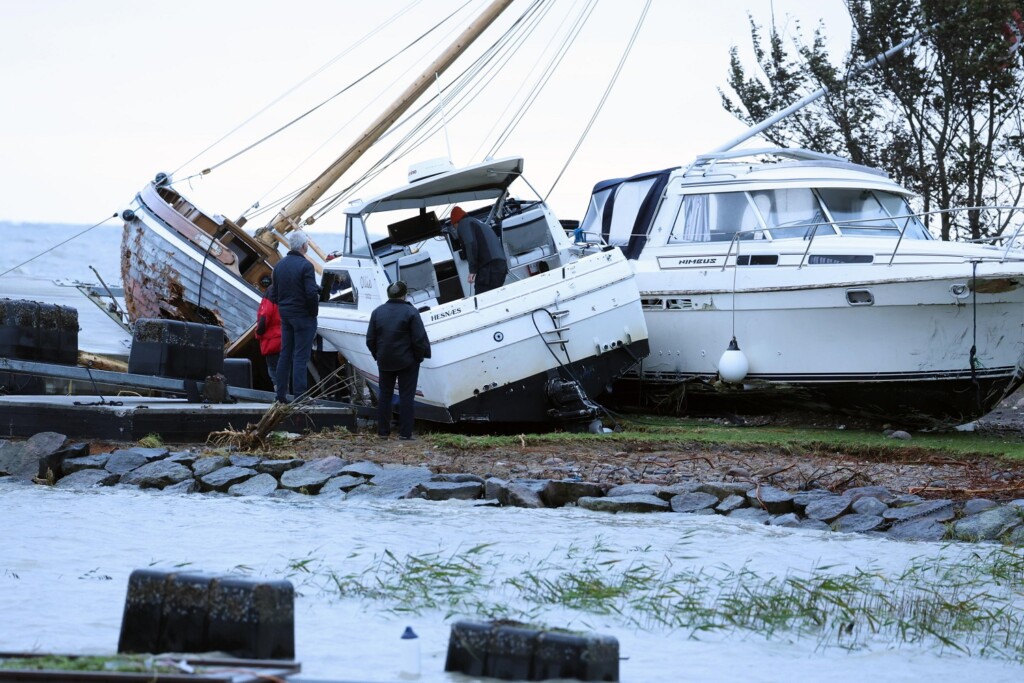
xmin=581 ymin=148 xmax=1024 ymax=423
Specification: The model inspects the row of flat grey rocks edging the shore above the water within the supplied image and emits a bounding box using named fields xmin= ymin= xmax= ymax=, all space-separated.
xmin=0 ymin=432 xmax=1024 ymax=546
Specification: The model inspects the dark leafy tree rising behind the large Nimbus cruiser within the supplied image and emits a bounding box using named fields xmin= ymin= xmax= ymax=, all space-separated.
xmin=720 ymin=0 xmax=1024 ymax=240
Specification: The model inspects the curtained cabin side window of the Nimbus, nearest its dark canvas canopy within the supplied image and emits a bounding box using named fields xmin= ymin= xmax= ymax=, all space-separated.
xmin=669 ymin=193 xmax=763 ymax=243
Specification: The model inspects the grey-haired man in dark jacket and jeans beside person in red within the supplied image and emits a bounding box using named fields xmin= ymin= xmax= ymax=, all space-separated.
xmin=273 ymin=230 xmax=319 ymax=403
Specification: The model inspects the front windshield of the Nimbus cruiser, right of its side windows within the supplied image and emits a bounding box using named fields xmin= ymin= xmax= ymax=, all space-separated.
xmin=818 ymin=187 xmax=931 ymax=240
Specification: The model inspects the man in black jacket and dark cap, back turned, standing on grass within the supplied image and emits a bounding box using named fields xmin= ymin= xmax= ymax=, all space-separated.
xmin=367 ymin=280 xmax=430 ymax=441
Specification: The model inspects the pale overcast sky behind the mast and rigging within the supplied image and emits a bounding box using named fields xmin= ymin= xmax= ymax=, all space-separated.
xmin=0 ymin=0 xmax=850 ymax=224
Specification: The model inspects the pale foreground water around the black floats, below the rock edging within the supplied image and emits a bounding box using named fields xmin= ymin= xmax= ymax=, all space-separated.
xmin=0 ymin=483 xmax=1024 ymax=683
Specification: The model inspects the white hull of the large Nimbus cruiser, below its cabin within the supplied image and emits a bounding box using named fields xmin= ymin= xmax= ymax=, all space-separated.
xmin=624 ymin=243 xmax=1024 ymax=423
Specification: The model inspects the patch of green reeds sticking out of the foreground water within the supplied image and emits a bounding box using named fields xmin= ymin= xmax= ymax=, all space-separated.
xmin=292 ymin=542 xmax=1024 ymax=661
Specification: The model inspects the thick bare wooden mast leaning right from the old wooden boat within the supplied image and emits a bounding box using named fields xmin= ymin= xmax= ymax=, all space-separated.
xmin=256 ymin=0 xmax=512 ymax=244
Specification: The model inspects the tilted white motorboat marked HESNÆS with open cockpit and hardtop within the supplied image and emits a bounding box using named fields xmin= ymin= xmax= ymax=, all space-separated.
xmin=318 ymin=158 xmax=648 ymax=423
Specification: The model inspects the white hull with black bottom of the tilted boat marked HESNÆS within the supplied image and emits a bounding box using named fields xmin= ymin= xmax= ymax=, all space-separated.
xmin=318 ymin=250 xmax=648 ymax=423
